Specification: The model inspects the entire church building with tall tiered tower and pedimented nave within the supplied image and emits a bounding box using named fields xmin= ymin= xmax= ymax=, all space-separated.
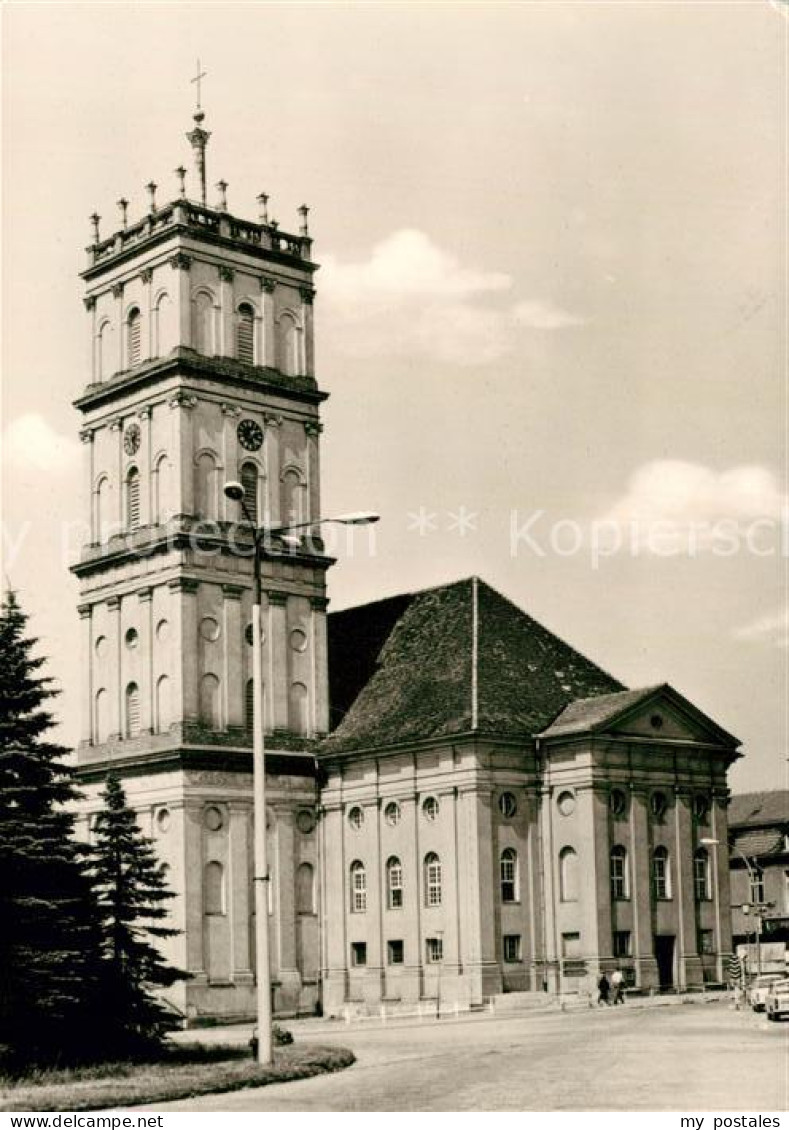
xmin=73 ymin=108 xmax=738 ymax=1022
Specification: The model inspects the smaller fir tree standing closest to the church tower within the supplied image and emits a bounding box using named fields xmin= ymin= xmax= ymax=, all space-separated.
xmin=92 ymin=774 xmax=187 ymax=1054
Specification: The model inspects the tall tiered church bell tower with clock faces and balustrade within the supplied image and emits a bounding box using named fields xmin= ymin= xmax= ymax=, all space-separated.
xmin=72 ymin=102 xmax=331 ymax=1019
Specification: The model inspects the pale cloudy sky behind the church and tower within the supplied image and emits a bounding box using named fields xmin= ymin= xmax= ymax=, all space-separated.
xmin=2 ymin=0 xmax=789 ymax=792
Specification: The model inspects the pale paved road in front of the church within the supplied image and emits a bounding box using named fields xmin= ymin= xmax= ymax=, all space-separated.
xmin=141 ymin=1003 xmax=789 ymax=1113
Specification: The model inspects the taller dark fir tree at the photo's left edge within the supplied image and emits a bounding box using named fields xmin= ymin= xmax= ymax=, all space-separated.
xmin=0 ymin=592 xmax=99 ymax=1066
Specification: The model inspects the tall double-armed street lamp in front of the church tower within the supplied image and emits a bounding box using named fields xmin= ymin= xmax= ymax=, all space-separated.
xmin=224 ymin=481 xmax=379 ymax=1066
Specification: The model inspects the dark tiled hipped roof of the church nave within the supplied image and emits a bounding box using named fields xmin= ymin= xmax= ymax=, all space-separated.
xmin=319 ymin=577 xmax=623 ymax=756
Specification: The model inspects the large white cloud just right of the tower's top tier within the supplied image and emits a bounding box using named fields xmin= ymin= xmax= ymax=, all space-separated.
xmin=321 ymin=228 xmax=582 ymax=365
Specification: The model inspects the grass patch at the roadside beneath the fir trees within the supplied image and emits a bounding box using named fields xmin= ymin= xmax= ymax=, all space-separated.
xmin=0 ymin=1043 xmax=355 ymax=1111
